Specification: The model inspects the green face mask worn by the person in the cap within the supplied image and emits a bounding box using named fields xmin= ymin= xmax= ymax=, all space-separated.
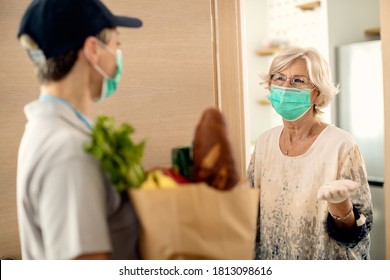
xmin=94 ymin=49 xmax=123 ymax=102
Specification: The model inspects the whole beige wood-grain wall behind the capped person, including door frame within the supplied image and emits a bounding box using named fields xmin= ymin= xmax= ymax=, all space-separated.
xmin=0 ymin=0 xmax=245 ymax=258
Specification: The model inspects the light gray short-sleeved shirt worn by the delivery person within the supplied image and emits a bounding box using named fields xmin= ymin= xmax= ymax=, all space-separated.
xmin=17 ymin=100 xmax=139 ymax=259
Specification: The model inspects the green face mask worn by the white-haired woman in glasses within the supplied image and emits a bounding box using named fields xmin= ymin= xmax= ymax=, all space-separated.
xmin=268 ymin=85 xmax=312 ymax=121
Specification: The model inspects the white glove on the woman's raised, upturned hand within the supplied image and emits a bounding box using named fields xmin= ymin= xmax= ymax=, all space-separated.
xmin=317 ymin=179 xmax=359 ymax=203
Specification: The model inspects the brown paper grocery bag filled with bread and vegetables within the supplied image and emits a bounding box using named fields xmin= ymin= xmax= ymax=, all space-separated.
xmin=129 ymin=184 xmax=259 ymax=260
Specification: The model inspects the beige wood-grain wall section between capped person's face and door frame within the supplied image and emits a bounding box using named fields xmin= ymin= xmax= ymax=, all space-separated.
xmin=94 ymin=0 xmax=217 ymax=168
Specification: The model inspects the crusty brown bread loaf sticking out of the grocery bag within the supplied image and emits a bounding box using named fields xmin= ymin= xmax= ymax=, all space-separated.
xmin=193 ymin=108 xmax=239 ymax=190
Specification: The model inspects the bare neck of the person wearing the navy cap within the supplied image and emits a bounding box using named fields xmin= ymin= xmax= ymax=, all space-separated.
xmin=41 ymin=74 xmax=90 ymax=116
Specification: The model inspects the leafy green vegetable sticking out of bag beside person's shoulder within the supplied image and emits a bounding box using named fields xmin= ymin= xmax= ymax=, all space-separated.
xmin=85 ymin=116 xmax=146 ymax=192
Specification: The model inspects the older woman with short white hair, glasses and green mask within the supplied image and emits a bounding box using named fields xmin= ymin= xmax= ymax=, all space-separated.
xmin=247 ymin=48 xmax=373 ymax=259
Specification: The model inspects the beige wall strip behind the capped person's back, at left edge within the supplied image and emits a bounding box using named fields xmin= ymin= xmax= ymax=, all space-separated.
xmin=0 ymin=0 xmax=38 ymax=257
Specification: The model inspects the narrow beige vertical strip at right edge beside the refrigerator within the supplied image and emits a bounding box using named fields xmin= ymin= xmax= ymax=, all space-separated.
xmin=380 ymin=0 xmax=390 ymax=260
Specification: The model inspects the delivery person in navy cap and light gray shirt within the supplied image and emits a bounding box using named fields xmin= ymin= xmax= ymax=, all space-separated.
xmin=17 ymin=0 xmax=142 ymax=259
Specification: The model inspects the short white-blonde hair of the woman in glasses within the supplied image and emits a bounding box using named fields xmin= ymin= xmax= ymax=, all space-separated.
xmin=262 ymin=47 xmax=340 ymax=114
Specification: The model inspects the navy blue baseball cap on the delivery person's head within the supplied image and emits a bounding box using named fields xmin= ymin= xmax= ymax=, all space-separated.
xmin=18 ymin=0 xmax=142 ymax=58
